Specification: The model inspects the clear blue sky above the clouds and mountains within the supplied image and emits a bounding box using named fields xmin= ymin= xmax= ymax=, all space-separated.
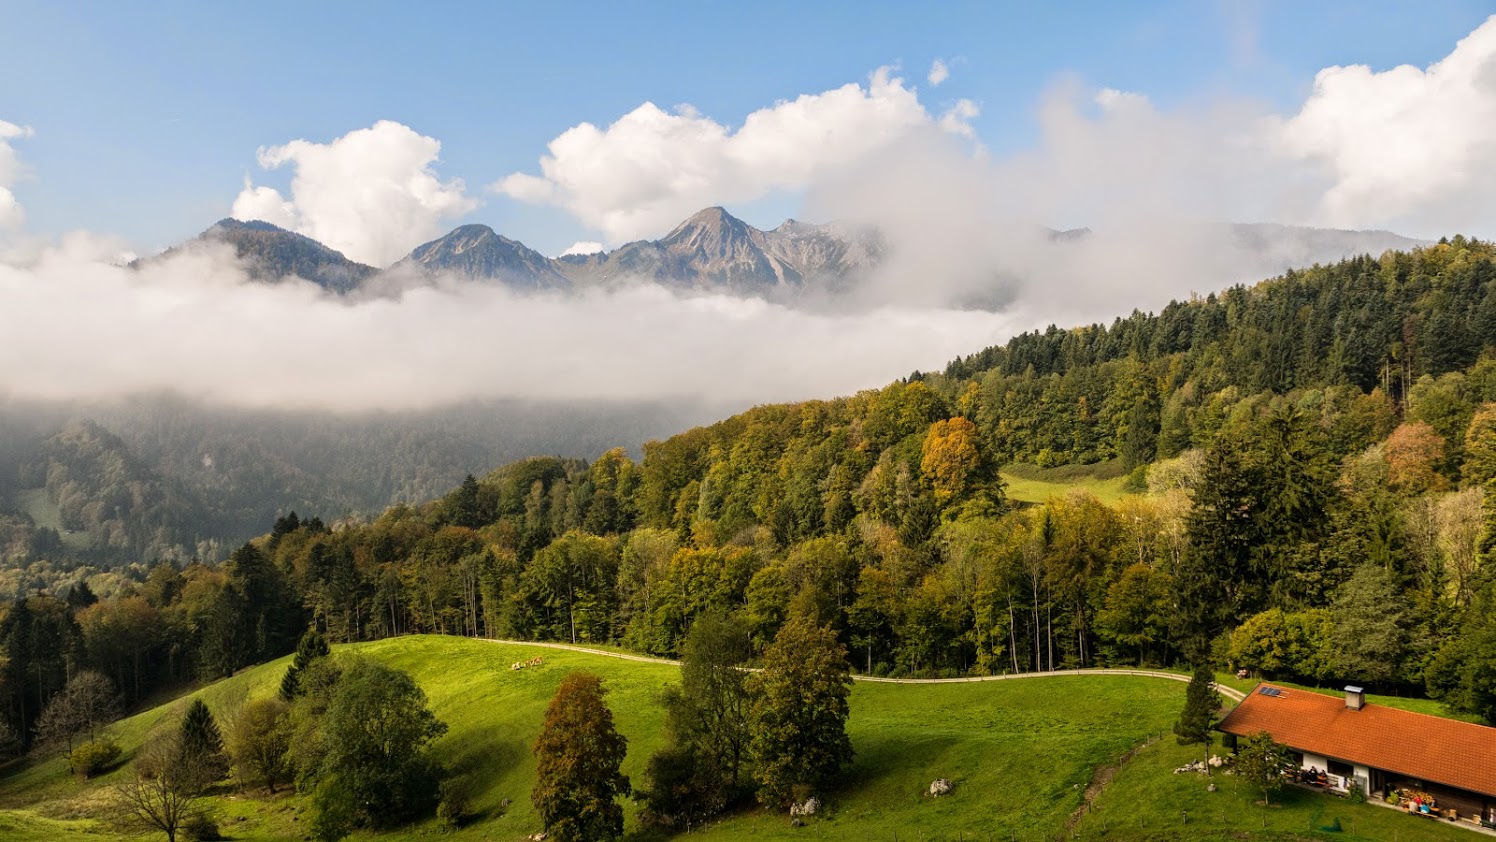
xmin=0 ymin=1 xmax=1492 ymax=253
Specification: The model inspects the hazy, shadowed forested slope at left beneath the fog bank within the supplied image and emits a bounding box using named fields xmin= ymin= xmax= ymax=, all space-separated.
xmin=0 ymin=396 xmax=721 ymax=577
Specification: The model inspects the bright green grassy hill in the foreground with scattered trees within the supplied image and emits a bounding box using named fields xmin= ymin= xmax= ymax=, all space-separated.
xmin=0 ymin=637 xmax=1468 ymax=842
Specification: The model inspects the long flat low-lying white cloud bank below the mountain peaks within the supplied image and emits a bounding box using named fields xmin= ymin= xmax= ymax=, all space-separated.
xmin=0 ymin=245 xmax=1010 ymax=410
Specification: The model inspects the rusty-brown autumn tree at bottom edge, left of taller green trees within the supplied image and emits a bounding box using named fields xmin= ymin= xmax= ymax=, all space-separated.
xmin=530 ymin=673 xmax=630 ymax=842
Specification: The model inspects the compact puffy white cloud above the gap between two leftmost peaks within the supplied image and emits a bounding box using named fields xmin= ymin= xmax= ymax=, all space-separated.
xmin=232 ymin=120 xmax=477 ymax=266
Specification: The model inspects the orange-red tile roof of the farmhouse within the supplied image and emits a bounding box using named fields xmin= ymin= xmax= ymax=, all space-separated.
xmin=1216 ymin=685 xmax=1496 ymax=796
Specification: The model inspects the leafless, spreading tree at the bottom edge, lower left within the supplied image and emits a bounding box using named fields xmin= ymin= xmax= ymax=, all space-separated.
xmin=114 ymin=733 xmax=209 ymax=842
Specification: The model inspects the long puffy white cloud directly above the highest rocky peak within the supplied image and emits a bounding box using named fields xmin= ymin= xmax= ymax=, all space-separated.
xmin=491 ymin=67 xmax=932 ymax=244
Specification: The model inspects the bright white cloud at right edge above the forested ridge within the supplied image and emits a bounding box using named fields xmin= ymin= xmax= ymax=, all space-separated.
xmin=1275 ymin=16 xmax=1496 ymax=233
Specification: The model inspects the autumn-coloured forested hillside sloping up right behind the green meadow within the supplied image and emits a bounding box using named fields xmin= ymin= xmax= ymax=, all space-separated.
xmin=0 ymin=238 xmax=1496 ymax=750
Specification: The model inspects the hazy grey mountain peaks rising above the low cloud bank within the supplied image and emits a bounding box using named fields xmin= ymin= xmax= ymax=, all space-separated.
xmin=145 ymin=208 xmax=1423 ymax=298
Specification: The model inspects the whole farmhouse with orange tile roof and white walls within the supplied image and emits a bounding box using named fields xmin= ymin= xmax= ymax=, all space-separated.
xmin=1216 ymin=683 xmax=1496 ymax=827
